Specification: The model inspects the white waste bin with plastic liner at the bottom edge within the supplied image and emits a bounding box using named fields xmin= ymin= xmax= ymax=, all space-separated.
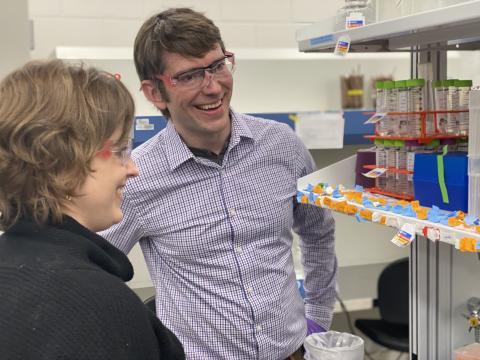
xmin=303 ymin=331 xmax=364 ymax=360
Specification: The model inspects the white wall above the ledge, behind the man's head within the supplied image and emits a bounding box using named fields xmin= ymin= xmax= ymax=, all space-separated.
xmin=29 ymin=0 xmax=343 ymax=58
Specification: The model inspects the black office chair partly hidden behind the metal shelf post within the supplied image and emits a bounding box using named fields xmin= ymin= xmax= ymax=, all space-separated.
xmin=355 ymin=258 xmax=409 ymax=353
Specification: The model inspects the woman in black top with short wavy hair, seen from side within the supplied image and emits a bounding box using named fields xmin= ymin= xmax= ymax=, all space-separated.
xmin=0 ymin=60 xmax=185 ymax=360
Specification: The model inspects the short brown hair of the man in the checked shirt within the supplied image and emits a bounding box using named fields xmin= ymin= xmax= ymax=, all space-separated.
xmin=133 ymin=8 xmax=225 ymax=118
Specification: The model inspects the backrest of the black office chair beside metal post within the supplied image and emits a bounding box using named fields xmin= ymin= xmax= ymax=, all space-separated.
xmin=377 ymin=258 xmax=409 ymax=325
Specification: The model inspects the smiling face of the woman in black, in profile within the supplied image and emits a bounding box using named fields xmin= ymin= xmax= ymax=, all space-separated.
xmin=65 ymin=130 xmax=138 ymax=232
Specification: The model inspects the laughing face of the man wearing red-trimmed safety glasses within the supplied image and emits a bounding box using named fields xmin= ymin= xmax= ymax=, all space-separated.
xmin=152 ymin=45 xmax=233 ymax=147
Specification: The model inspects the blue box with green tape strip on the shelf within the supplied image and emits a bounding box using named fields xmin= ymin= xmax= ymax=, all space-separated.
xmin=413 ymin=153 xmax=468 ymax=212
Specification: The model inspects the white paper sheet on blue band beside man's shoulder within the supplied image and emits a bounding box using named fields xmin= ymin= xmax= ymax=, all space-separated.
xmin=295 ymin=112 xmax=345 ymax=149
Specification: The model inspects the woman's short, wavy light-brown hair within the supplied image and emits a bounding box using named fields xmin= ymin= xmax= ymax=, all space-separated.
xmin=0 ymin=60 xmax=135 ymax=230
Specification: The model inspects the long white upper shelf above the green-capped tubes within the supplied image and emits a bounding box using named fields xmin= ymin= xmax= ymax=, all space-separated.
xmin=297 ymin=0 xmax=480 ymax=52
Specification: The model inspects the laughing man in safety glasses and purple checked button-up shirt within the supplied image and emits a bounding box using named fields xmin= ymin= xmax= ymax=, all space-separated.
xmin=103 ymin=9 xmax=336 ymax=360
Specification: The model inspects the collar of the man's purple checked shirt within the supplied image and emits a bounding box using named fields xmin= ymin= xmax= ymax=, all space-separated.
xmin=164 ymin=110 xmax=253 ymax=171
